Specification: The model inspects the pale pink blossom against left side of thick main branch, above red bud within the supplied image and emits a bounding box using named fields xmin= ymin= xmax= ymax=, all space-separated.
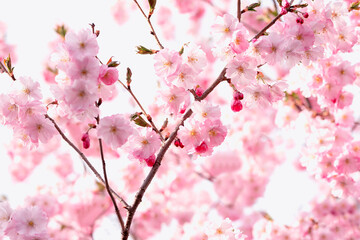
xmin=128 ymin=128 xmax=161 ymax=160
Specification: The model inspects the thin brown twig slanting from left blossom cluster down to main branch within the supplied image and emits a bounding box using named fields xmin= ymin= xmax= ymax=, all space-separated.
xmin=45 ymin=114 xmax=130 ymax=208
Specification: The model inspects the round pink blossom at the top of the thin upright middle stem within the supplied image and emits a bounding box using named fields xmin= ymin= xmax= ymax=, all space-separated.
xmin=97 ymin=114 xmax=134 ymax=149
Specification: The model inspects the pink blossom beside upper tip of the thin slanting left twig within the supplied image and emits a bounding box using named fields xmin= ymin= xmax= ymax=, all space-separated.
xmin=24 ymin=115 xmax=56 ymax=143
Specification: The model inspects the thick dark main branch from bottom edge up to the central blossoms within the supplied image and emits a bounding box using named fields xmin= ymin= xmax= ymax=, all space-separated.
xmin=122 ymin=109 xmax=193 ymax=240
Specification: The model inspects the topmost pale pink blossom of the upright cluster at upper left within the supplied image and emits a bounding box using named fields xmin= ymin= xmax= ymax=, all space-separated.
xmin=65 ymin=29 xmax=99 ymax=60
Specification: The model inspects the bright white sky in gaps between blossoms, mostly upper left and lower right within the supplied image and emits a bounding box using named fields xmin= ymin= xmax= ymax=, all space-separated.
xmin=0 ymin=0 xmax=322 ymax=237
